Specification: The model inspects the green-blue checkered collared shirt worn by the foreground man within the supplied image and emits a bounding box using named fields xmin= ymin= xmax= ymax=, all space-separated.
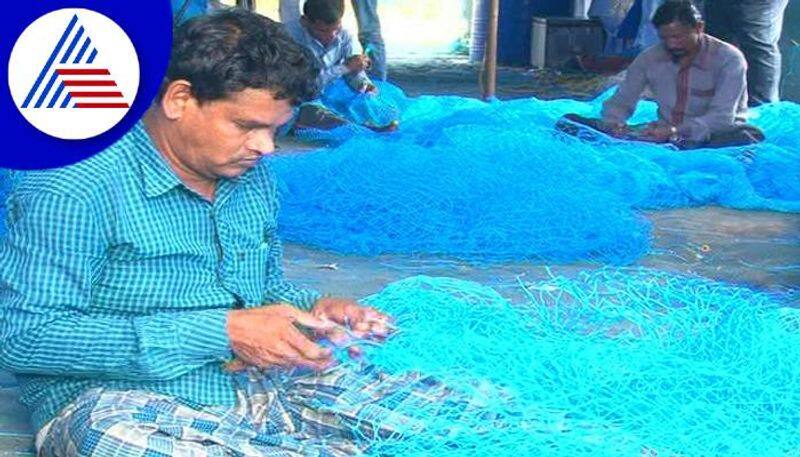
xmin=0 ymin=124 xmax=319 ymax=428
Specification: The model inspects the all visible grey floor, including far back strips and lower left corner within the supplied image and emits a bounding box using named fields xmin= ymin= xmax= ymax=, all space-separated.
xmin=0 ymin=59 xmax=800 ymax=457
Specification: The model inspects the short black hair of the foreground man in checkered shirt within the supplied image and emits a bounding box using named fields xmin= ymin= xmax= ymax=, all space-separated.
xmin=159 ymin=8 xmax=319 ymax=105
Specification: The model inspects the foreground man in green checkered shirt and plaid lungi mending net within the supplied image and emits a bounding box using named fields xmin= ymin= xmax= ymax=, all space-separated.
xmin=0 ymin=10 xmax=450 ymax=456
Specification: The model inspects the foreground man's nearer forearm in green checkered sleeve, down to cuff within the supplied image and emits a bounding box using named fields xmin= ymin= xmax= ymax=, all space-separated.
xmin=0 ymin=308 xmax=231 ymax=381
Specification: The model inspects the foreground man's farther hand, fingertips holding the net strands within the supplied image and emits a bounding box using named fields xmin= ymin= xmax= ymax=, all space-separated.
xmin=311 ymin=297 xmax=390 ymax=339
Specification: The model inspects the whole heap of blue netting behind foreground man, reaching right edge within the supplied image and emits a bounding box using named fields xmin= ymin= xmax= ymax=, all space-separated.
xmin=272 ymin=80 xmax=800 ymax=264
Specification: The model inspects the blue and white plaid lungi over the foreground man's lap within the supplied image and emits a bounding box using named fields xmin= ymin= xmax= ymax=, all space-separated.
xmin=37 ymin=364 xmax=462 ymax=457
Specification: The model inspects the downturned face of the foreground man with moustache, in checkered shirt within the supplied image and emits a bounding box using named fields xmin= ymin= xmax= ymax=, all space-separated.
xmin=175 ymin=89 xmax=292 ymax=180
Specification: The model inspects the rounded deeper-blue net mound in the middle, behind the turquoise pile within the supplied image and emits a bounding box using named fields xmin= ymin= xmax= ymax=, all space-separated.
xmin=272 ymin=125 xmax=649 ymax=263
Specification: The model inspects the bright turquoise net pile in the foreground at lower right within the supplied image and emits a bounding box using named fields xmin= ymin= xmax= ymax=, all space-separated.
xmin=331 ymin=269 xmax=800 ymax=457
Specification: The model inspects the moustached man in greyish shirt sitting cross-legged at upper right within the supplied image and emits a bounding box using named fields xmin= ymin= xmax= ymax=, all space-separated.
xmin=560 ymin=0 xmax=764 ymax=148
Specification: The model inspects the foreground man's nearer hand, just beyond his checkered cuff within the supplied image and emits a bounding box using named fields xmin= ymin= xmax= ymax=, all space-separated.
xmin=227 ymin=305 xmax=335 ymax=371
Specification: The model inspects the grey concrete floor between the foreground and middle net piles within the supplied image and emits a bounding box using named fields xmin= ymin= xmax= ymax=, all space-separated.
xmin=285 ymin=208 xmax=800 ymax=305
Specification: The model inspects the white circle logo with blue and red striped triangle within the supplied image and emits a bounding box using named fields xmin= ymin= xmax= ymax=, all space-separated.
xmin=8 ymin=8 xmax=139 ymax=140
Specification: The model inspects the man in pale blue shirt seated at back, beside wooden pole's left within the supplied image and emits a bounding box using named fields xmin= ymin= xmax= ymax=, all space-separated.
xmin=286 ymin=0 xmax=397 ymax=131
